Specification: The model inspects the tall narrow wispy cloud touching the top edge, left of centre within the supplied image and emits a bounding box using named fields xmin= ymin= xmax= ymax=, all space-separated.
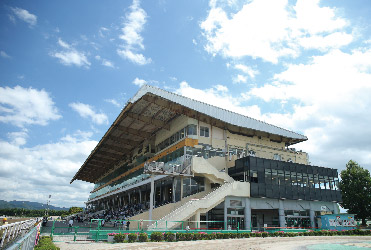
xmin=117 ymin=0 xmax=152 ymax=65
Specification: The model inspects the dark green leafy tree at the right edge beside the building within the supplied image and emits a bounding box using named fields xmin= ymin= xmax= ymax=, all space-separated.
xmin=339 ymin=160 xmax=371 ymax=226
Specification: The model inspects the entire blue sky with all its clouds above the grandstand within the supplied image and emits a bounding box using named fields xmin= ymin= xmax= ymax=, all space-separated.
xmin=0 ymin=0 xmax=371 ymax=206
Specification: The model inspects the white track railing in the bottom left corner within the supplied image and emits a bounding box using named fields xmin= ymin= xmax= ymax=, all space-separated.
xmin=0 ymin=219 xmax=36 ymax=249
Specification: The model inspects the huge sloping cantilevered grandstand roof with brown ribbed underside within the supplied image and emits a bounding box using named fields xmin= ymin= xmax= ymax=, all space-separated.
xmin=71 ymin=85 xmax=307 ymax=183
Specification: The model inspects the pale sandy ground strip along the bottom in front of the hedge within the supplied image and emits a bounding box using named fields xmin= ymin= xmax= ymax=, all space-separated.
xmin=55 ymin=236 xmax=371 ymax=250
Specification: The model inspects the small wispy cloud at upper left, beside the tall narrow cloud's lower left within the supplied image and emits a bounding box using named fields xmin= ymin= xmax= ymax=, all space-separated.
xmin=50 ymin=38 xmax=90 ymax=68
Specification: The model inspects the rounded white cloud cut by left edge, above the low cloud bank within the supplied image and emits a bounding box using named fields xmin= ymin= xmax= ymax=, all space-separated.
xmin=0 ymin=86 xmax=61 ymax=127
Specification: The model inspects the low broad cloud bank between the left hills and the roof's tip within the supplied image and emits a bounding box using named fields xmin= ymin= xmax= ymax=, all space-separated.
xmin=0 ymin=131 xmax=97 ymax=207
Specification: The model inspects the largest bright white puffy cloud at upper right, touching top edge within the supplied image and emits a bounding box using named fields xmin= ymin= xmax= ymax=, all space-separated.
xmin=200 ymin=0 xmax=353 ymax=63
